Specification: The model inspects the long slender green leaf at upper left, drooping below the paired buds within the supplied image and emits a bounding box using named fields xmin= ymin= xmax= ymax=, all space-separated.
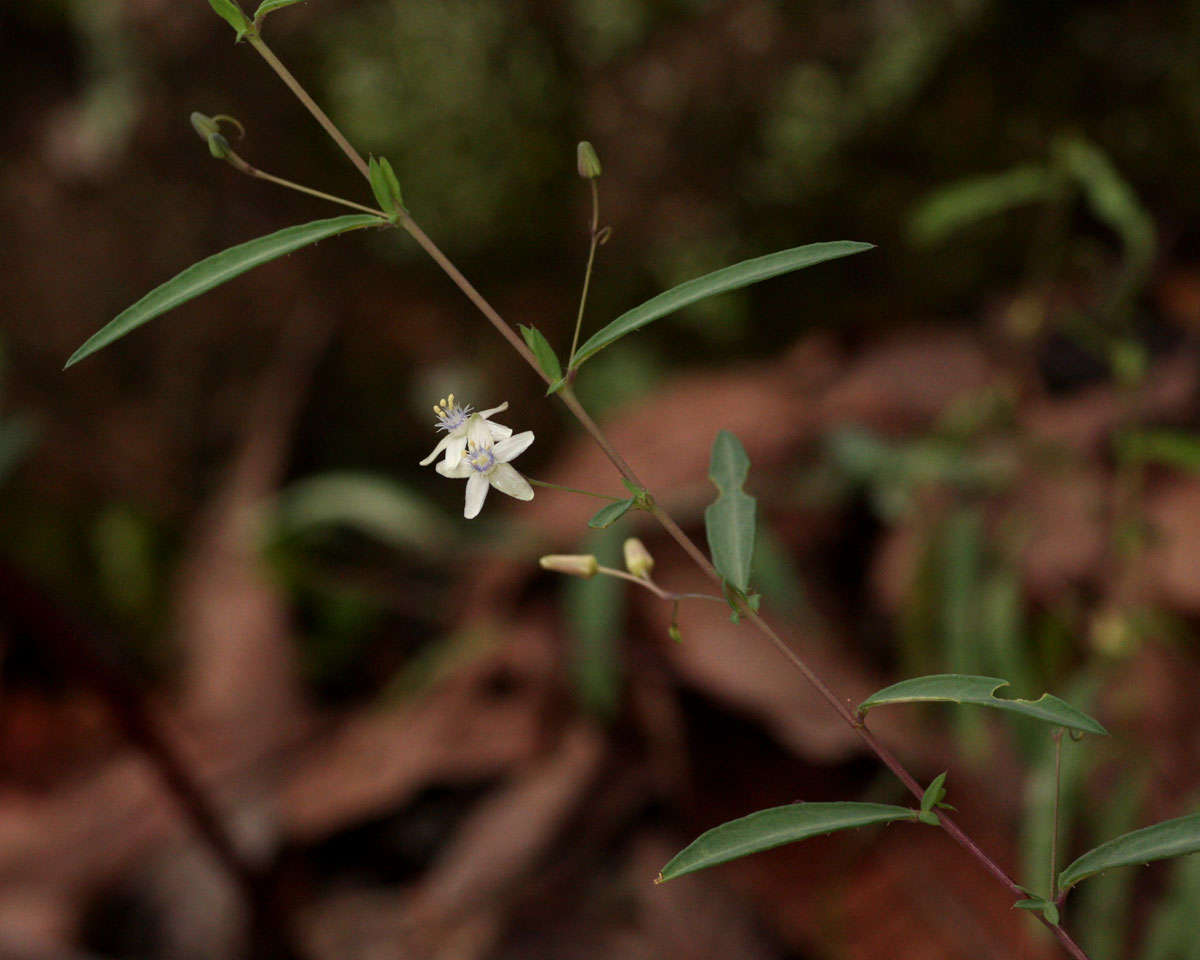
xmin=64 ymin=214 xmax=385 ymax=368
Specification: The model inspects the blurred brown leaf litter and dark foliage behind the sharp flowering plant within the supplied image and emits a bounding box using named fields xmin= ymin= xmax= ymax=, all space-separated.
xmin=0 ymin=0 xmax=1200 ymax=960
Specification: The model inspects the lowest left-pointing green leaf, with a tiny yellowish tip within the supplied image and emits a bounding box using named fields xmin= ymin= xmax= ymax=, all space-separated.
xmin=655 ymin=802 xmax=917 ymax=883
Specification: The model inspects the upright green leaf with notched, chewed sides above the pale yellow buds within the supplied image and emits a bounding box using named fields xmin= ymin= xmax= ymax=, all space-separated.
xmin=704 ymin=430 xmax=755 ymax=593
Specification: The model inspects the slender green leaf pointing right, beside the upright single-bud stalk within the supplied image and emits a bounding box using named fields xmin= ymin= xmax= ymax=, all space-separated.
xmin=571 ymin=240 xmax=874 ymax=370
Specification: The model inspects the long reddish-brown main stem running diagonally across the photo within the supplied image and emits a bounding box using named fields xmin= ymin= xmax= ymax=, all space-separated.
xmin=238 ymin=41 xmax=1088 ymax=960
